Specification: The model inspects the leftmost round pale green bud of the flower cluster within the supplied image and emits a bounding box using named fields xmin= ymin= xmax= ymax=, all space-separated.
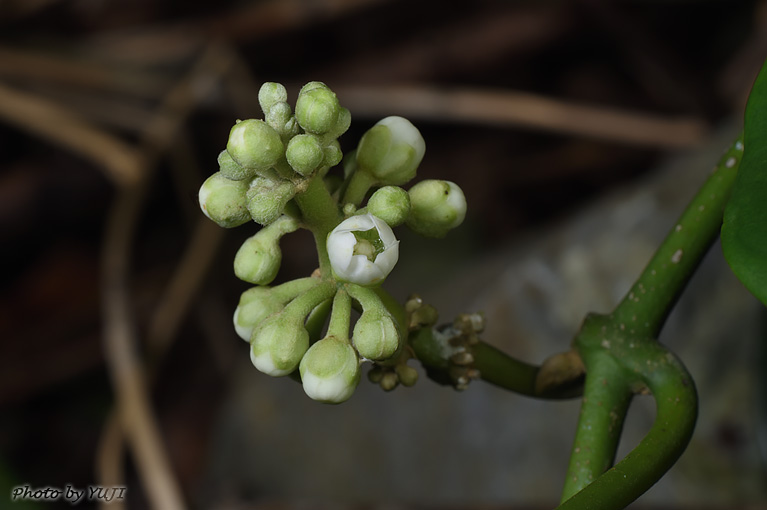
xmin=199 ymin=172 xmax=250 ymax=228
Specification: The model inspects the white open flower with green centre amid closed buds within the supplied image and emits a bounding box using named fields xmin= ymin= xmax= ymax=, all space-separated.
xmin=327 ymin=214 xmax=399 ymax=285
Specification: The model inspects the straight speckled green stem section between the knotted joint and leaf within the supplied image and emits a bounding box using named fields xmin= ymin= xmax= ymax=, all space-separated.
xmin=613 ymin=134 xmax=743 ymax=338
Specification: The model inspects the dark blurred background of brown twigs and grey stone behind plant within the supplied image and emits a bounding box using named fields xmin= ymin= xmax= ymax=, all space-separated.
xmin=0 ymin=0 xmax=767 ymax=509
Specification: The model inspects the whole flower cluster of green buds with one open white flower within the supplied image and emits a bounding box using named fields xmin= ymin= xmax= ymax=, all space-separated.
xmin=199 ymin=82 xmax=466 ymax=403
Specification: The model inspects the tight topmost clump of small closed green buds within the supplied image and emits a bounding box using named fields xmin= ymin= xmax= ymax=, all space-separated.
xmin=199 ymin=82 xmax=351 ymax=228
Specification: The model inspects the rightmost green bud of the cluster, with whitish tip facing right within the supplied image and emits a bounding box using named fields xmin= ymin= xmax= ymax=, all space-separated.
xmin=407 ymin=180 xmax=466 ymax=237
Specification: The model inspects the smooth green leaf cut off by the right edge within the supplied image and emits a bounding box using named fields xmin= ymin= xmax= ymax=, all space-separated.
xmin=722 ymin=62 xmax=767 ymax=305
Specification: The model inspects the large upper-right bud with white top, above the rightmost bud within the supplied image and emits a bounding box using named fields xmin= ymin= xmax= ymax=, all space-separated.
xmin=357 ymin=117 xmax=426 ymax=185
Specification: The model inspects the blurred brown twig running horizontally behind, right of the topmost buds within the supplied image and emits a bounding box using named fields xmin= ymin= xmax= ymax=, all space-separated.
xmin=334 ymin=86 xmax=706 ymax=148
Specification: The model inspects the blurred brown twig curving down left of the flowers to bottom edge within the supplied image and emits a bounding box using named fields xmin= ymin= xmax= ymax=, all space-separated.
xmin=99 ymin=45 xmax=237 ymax=510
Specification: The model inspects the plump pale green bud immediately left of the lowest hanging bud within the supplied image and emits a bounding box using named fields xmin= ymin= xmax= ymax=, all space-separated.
xmin=250 ymin=311 xmax=309 ymax=377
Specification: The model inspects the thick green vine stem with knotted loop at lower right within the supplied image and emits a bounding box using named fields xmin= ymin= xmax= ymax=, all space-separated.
xmin=562 ymin=135 xmax=743 ymax=509
